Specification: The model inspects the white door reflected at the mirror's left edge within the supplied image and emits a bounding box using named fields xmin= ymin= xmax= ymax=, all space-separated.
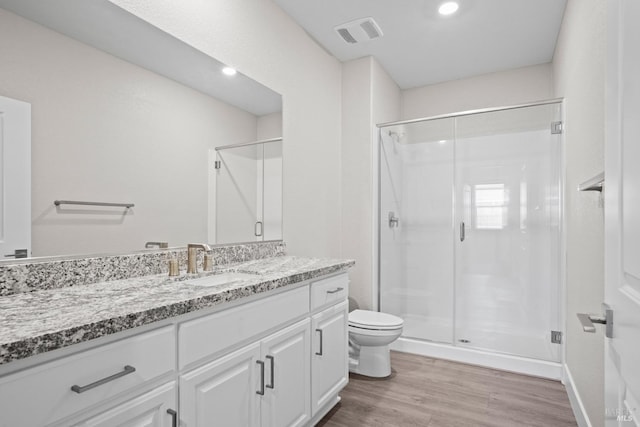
xmin=0 ymin=96 xmax=31 ymax=259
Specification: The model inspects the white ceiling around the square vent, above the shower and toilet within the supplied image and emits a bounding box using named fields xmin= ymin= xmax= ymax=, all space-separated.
xmin=274 ymin=0 xmax=566 ymax=89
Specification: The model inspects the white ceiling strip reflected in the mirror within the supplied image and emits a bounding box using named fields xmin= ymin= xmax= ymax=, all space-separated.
xmin=0 ymin=0 xmax=282 ymax=116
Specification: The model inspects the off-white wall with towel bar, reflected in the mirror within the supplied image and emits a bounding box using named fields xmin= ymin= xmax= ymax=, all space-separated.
xmin=0 ymin=10 xmax=257 ymax=256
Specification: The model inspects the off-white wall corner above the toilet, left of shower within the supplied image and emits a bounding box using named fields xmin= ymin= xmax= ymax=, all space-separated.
xmin=342 ymin=57 xmax=400 ymax=309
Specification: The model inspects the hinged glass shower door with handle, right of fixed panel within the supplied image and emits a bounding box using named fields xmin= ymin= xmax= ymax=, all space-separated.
xmin=455 ymin=104 xmax=560 ymax=361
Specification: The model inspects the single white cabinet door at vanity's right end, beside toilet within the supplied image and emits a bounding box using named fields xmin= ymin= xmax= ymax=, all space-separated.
xmin=311 ymin=301 xmax=349 ymax=414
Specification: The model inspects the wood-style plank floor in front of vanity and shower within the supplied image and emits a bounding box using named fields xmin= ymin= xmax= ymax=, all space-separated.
xmin=318 ymin=352 xmax=577 ymax=427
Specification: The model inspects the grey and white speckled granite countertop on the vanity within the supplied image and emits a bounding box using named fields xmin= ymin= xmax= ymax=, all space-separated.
xmin=0 ymin=256 xmax=354 ymax=365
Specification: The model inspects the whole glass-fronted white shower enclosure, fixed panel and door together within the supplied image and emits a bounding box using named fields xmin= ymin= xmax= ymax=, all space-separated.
xmin=378 ymin=100 xmax=562 ymax=374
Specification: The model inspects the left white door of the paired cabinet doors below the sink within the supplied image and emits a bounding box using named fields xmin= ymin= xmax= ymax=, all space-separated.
xmin=180 ymin=343 xmax=261 ymax=427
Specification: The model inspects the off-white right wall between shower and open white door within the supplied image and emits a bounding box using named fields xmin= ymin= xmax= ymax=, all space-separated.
xmin=553 ymin=0 xmax=606 ymax=426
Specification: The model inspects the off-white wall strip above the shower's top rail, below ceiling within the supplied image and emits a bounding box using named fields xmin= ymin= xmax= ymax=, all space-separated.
xmin=402 ymin=64 xmax=554 ymax=120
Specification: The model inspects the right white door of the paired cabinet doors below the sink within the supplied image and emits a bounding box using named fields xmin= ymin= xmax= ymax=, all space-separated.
xmin=262 ymin=319 xmax=311 ymax=427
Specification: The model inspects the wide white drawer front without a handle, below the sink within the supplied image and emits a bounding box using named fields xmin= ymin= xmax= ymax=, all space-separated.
xmin=178 ymin=285 xmax=309 ymax=369
